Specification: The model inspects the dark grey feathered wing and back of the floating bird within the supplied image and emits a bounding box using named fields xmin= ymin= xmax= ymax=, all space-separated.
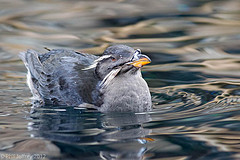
xmin=20 ymin=49 xmax=98 ymax=106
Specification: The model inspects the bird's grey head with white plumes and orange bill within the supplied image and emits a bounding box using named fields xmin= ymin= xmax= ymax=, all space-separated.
xmin=83 ymin=45 xmax=151 ymax=87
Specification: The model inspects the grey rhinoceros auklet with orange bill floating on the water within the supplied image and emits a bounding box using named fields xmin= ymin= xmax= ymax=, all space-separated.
xmin=20 ymin=45 xmax=152 ymax=112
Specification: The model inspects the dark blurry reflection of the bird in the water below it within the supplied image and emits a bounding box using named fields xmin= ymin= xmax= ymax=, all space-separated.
xmin=29 ymin=106 xmax=153 ymax=159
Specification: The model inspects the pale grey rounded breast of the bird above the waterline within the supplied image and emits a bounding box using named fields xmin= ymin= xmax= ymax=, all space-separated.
xmin=100 ymin=71 xmax=152 ymax=112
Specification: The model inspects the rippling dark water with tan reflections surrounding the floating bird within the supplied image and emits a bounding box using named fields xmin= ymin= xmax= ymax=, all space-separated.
xmin=0 ymin=0 xmax=240 ymax=160
